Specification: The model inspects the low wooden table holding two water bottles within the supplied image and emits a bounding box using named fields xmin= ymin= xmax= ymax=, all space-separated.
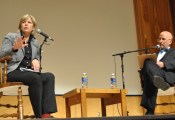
xmin=63 ymin=88 xmax=127 ymax=117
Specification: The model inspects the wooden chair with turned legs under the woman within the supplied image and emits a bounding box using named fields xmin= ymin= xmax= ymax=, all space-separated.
xmin=0 ymin=56 xmax=28 ymax=119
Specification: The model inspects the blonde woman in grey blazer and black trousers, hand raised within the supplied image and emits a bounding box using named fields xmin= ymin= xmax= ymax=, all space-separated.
xmin=2 ymin=14 xmax=57 ymax=118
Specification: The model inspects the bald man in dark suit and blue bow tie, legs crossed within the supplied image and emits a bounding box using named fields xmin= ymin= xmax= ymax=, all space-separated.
xmin=140 ymin=31 xmax=175 ymax=115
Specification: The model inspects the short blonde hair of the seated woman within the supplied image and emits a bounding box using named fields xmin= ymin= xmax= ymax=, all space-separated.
xmin=18 ymin=14 xmax=37 ymax=32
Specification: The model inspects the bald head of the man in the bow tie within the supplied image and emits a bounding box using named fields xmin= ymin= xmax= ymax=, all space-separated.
xmin=157 ymin=31 xmax=173 ymax=48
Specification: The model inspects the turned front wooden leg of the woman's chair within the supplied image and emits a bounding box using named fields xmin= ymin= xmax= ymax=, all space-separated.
xmin=17 ymin=87 xmax=24 ymax=119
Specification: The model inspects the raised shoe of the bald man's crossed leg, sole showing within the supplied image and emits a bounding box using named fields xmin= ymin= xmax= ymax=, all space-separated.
xmin=153 ymin=76 xmax=170 ymax=91
